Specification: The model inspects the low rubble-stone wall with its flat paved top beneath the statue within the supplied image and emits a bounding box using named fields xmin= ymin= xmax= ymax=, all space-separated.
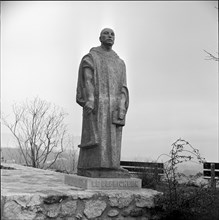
xmin=1 ymin=164 xmax=162 ymax=220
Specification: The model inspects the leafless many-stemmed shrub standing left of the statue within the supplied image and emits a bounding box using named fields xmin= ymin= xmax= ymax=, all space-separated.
xmin=3 ymin=98 xmax=66 ymax=168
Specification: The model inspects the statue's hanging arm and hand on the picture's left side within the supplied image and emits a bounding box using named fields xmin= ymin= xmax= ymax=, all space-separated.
xmin=83 ymin=67 xmax=94 ymax=114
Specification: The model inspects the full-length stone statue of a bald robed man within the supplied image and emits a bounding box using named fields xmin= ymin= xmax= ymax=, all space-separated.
xmin=76 ymin=28 xmax=130 ymax=178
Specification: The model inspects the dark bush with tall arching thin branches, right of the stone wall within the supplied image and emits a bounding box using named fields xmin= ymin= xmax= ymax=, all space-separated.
xmin=156 ymin=139 xmax=219 ymax=220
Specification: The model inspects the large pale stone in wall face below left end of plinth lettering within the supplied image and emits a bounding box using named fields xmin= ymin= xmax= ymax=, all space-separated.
xmin=84 ymin=200 xmax=107 ymax=218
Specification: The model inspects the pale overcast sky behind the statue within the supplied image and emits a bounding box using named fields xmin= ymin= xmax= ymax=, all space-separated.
xmin=1 ymin=1 xmax=219 ymax=161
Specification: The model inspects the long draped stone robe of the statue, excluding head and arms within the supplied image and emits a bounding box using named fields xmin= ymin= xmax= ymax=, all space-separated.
xmin=76 ymin=47 xmax=129 ymax=173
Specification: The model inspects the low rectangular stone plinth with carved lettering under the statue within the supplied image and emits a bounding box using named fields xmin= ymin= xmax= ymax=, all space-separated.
xmin=65 ymin=175 xmax=141 ymax=190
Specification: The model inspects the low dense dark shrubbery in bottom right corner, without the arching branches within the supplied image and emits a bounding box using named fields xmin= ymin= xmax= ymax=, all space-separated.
xmin=156 ymin=186 xmax=219 ymax=220
